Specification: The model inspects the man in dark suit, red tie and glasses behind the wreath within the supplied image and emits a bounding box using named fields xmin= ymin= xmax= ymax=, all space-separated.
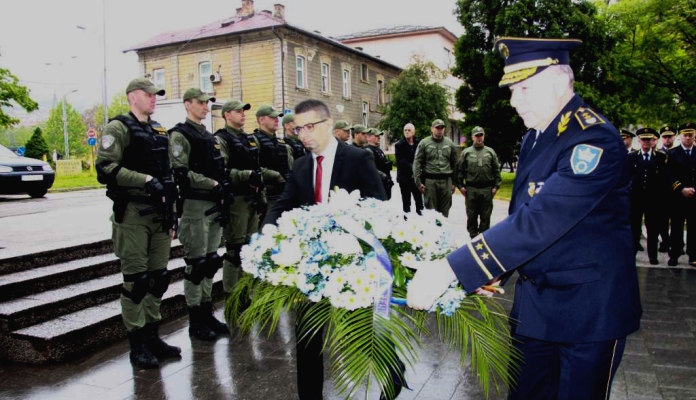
xmin=262 ymin=100 xmax=403 ymax=400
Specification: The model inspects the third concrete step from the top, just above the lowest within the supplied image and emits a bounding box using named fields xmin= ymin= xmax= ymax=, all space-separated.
xmin=0 ymin=258 xmax=186 ymax=332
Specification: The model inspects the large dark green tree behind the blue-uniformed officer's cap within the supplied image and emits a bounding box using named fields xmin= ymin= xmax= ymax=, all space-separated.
xmin=452 ymin=0 xmax=626 ymax=152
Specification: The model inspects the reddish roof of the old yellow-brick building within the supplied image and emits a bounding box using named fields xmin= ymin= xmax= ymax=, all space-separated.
xmin=123 ymin=10 xmax=401 ymax=71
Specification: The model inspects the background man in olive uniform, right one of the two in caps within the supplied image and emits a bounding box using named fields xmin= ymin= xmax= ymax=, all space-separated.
xmin=455 ymin=126 xmax=502 ymax=238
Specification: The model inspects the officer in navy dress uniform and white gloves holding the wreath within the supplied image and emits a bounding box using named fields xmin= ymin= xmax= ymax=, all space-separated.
xmin=408 ymin=38 xmax=642 ymax=400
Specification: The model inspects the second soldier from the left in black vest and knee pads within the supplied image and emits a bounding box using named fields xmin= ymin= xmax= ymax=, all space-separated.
xmin=169 ymin=88 xmax=228 ymax=340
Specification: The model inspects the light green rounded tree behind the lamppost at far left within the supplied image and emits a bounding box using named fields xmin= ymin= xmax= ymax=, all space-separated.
xmin=45 ymin=99 xmax=89 ymax=158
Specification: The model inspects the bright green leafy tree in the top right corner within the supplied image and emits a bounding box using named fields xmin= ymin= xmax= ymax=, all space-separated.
xmin=603 ymin=0 xmax=696 ymax=127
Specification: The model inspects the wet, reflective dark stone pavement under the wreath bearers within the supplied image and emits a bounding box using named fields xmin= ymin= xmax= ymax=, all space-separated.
xmin=0 ymin=188 xmax=696 ymax=400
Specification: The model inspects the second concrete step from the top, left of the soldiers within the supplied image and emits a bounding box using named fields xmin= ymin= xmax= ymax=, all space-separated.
xmin=0 ymin=240 xmax=184 ymax=301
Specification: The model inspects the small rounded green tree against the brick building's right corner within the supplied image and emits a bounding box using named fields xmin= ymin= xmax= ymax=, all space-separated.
xmin=379 ymin=59 xmax=447 ymax=141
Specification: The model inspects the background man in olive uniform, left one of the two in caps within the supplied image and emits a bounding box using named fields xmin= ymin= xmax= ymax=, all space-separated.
xmin=413 ymin=119 xmax=457 ymax=217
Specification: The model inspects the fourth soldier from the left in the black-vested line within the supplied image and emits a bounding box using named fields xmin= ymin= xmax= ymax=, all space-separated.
xmin=254 ymin=105 xmax=293 ymax=221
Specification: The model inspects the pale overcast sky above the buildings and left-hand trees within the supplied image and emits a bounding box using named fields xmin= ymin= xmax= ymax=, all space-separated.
xmin=0 ymin=0 xmax=462 ymax=119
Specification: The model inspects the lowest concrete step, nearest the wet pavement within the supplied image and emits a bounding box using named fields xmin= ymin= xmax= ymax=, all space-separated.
xmin=0 ymin=270 xmax=223 ymax=364
